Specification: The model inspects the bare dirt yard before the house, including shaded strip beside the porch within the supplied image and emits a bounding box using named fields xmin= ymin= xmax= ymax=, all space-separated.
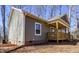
xmin=9 ymin=40 xmax=79 ymax=53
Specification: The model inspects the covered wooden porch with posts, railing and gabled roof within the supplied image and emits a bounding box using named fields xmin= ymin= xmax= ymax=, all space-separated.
xmin=47 ymin=14 xmax=70 ymax=43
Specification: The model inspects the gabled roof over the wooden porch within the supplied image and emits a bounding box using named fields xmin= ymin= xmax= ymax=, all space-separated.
xmin=48 ymin=14 xmax=70 ymax=28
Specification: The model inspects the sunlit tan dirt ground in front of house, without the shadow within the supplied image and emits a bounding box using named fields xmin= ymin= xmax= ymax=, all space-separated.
xmin=8 ymin=45 xmax=79 ymax=53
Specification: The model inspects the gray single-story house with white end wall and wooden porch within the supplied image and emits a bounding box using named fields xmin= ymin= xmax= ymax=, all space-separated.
xmin=8 ymin=7 xmax=70 ymax=45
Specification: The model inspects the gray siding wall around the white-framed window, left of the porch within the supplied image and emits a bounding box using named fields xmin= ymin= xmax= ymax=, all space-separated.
xmin=25 ymin=17 xmax=49 ymax=42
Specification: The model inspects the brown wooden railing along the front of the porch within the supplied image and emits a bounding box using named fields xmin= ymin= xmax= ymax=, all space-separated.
xmin=47 ymin=32 xmax=70 ymax=40
